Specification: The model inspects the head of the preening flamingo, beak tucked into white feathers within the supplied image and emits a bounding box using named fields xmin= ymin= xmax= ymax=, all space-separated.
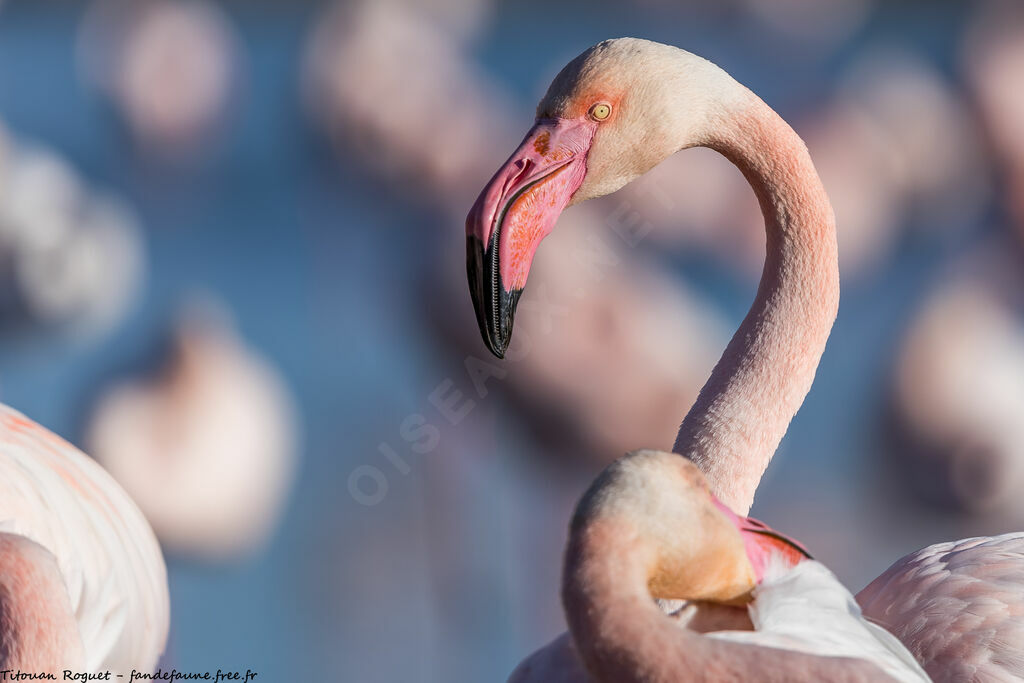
xmin=565 ymin=451 xmax=810 ymax=603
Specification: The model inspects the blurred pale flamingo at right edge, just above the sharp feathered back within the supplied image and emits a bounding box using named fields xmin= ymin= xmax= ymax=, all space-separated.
xmin=893 ymin=249 xmax=1024 ymax=521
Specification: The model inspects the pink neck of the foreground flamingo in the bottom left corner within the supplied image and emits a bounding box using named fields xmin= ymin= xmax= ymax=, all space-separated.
xmin=0 ymin=533 xmax=85 ymax=675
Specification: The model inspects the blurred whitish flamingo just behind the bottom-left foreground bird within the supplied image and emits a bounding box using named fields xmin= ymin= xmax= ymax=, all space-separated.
xmin=85 ymin=300 xmax=298 ymax=560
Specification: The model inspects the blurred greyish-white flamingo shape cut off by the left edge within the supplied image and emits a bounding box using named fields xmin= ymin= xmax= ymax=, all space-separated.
xmin=0 ymin=123 xmax=145 ymax=338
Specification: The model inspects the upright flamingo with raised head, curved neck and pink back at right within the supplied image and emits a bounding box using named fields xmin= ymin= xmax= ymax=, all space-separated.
xmin=466 ymin=39 xmax=1024 ymax=680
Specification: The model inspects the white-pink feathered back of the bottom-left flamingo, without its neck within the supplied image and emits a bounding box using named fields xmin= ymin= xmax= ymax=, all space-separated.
xmin=0 ymin=404 xmax=170 ymax=674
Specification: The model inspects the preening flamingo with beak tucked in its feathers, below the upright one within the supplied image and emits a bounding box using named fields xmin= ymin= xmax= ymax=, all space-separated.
xmin=510 ymin=451 xmax=928 ymax=683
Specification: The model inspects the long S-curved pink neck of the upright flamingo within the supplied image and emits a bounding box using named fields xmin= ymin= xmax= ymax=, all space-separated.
xmin=673 ymin=93 xmax=839 ymax=515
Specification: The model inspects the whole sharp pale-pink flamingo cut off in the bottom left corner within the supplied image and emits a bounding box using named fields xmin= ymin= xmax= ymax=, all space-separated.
xmin=0 ymin=404 xmax=170 ymax=676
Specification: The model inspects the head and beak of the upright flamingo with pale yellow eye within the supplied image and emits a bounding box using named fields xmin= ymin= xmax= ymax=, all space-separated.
xmin=466 ymin=38 xmax=745 ymax=357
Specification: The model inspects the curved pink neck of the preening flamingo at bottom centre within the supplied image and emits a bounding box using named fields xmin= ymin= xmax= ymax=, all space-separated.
xmin=562 ymin=528 xmax=888 ymax=683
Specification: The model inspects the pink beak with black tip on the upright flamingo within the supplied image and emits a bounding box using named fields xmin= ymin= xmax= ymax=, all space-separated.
xmin=466 ymin=117 xmax=597 ymax=358
